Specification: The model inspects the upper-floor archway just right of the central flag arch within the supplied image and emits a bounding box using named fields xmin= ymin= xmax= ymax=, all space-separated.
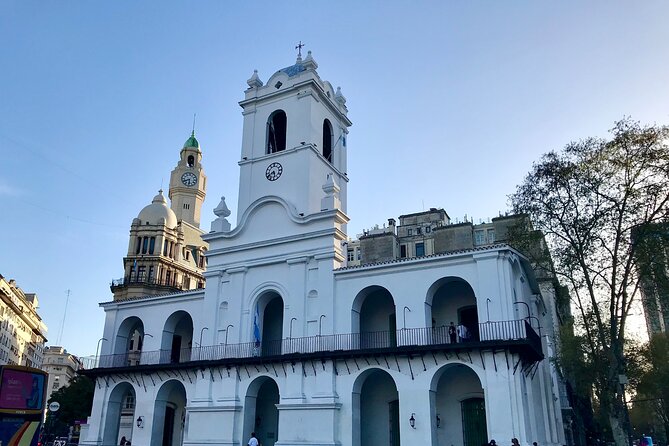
xmin=352 ymin=285 xmax=397 ymax=348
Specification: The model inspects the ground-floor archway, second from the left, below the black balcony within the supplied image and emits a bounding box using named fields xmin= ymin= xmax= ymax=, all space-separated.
xmin=150 ymin=380 xmax=187 ymax=446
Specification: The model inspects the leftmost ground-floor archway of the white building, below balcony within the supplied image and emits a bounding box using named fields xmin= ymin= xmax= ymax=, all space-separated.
xmin=102 ymin=382 xmax=136 ymax=445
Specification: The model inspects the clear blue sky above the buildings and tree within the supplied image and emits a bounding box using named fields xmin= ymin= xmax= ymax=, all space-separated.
xmin=0 ymin=0 xmax=669 ymax=356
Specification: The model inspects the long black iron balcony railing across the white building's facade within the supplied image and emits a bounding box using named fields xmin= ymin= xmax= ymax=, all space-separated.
xmin=97 ymin=320 xmax=543 ymax=368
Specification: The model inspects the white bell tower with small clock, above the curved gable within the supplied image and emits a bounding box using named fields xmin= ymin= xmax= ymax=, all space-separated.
xmin=237 ymin=51 xmax=351 ymax=222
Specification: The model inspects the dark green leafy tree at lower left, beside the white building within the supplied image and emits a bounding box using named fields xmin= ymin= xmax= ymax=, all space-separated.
xmin=46 ymin=375 xmax=95 ymax=436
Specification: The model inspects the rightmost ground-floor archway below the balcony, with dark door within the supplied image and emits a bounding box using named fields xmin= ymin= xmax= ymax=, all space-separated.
xmin=430 ymin=364 xmax=488 ymax=446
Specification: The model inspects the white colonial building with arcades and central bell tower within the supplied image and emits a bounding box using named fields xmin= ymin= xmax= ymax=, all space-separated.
xmin=82 ymin=54 xmax=565 ymax=446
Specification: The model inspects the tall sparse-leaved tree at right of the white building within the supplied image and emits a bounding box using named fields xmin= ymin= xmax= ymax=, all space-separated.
xmin=510 ymin=119 xmax=669 ymax=446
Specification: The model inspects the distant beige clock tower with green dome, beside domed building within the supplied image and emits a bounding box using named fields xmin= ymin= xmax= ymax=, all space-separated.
xmin=169 ymin=131 xmax=207 ymax=228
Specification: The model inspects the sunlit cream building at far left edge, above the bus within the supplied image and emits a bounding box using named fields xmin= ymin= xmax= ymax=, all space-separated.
xmin=0 ymin=275 xmax=47 ymax=368
